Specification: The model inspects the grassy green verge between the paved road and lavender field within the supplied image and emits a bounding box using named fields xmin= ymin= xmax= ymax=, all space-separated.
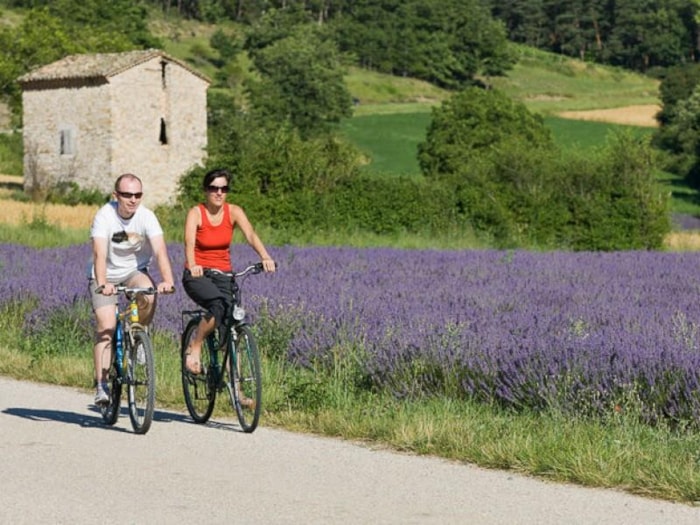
xmin=0 ymin=328 xmax=700 ymax=504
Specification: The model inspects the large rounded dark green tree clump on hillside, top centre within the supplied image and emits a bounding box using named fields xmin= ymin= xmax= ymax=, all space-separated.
xmin=333 ymin=0 xmax=514 ymax=88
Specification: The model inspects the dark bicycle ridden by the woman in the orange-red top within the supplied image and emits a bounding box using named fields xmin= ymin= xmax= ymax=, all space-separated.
xmin=180 ymin=263 xmax=263 ymax=433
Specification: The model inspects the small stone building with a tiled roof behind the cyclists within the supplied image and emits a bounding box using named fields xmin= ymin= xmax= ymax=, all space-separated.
xmin=19 ymin=49 xmax=209 ymax=206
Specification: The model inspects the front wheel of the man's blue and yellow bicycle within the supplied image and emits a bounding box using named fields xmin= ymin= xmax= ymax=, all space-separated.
xmin=125 ymin=330 xmax=156 ymax=434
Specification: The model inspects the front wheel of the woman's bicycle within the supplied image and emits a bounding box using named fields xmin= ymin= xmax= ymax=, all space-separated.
xmin=228 ymin=325 xmax=262 ymax=432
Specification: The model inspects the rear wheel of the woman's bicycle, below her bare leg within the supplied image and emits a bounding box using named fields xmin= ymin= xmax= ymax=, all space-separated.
xmin=180 ymin=318 xmax=216 ymax=423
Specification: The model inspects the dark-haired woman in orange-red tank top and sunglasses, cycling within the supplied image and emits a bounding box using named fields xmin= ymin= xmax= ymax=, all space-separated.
xmin=182 ymin=169 xmax=275 ymax=374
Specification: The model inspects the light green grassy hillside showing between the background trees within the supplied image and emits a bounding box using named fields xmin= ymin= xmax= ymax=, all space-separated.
xmin=145 ymin=16 xmax=659 ymax=123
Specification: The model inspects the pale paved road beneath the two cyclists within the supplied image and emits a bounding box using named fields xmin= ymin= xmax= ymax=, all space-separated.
xmin=0 ymin=377 xmax=700 ymax=525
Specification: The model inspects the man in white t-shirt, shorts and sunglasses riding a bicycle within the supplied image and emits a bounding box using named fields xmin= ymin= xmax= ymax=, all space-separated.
xmin=89 ymin=173 xmax=174 ymax=406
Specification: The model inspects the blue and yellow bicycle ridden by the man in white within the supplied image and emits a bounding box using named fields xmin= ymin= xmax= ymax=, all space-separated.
xmin=95 ymin=285 xmax=157 ymax=434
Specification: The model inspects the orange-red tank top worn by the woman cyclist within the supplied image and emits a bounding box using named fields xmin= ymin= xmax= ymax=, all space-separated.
xmin=194 ymin=204 xmax=233 ymax=272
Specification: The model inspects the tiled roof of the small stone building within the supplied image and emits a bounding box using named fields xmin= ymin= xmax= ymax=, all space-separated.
xmin=19 ymin=49 xmax=210 ymax=83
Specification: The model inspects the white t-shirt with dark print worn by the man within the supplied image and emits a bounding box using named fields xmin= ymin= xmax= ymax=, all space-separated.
xmin=90 ymin=201 xmax=163 ymax=283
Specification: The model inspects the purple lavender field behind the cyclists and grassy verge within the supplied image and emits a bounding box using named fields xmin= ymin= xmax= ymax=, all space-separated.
xmin=0 ymin=244 xmax=700 ymax=422
